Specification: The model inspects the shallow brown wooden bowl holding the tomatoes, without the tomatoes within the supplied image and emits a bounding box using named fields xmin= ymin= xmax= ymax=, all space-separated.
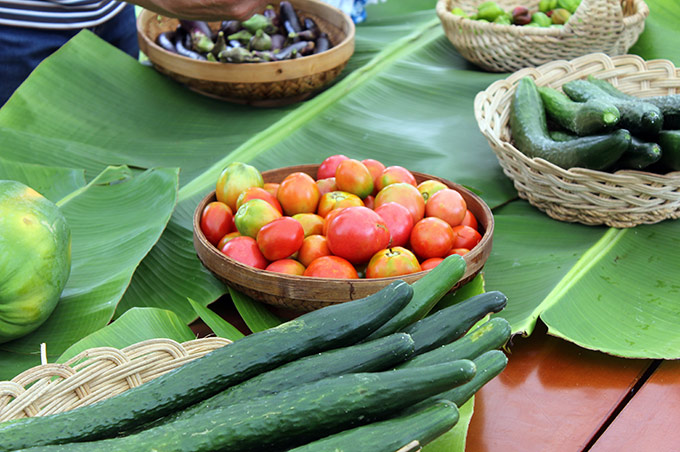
xmin=193 ymin=165 xmax=494 ymax=311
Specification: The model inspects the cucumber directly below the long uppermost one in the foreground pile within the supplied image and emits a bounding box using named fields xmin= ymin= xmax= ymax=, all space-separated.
xmin=147 ymin=333 xmax=414 ymax=425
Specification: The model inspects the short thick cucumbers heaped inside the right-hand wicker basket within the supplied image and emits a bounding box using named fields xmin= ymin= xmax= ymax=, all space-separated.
xmin=510 ymin=75 xmax=680 ymax=174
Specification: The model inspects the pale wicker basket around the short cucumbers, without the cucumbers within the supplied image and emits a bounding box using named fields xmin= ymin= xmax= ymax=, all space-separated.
xmin=474 ymin=54 xmax=680 ymax=228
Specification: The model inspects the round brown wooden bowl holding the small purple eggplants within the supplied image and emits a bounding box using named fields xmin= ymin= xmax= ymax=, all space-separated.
xmin=137 ymin=0 xmax=354 ymax=107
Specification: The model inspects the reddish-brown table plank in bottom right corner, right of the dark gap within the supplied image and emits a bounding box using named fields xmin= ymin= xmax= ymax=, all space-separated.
xmin=591 ymin=361 xmax=680 ymax=452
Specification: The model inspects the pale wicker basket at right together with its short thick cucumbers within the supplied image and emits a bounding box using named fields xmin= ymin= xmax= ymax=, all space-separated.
xmin=474 ymin=53 xmax=680 ymax=228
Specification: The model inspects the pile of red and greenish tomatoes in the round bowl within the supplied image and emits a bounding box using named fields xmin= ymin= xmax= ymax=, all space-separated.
xmin=200 ymin=154 xmax=482 ymax=279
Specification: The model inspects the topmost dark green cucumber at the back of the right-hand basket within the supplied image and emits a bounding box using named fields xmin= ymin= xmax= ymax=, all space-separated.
xmin=562 ymin=77 xmax=663 ymax=137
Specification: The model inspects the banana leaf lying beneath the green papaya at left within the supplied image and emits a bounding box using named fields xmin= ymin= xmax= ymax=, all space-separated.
xmin=0 ymin=164 xmax=178 ymax=379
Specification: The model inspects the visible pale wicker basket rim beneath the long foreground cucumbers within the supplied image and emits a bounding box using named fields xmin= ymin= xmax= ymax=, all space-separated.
xmin=0 ymin=337 xmax=231 ymax=422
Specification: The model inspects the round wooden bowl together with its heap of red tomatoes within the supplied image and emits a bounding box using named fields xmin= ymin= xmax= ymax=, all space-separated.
xmin=193 ymin=161 xmax=494 ymax=311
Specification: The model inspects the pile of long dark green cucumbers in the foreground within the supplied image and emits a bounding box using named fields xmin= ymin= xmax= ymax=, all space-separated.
xmin=0 ymin=256 xmax=510 ymax=452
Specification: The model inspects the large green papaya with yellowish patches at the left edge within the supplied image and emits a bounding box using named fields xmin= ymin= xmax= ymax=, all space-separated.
xmin=0 ymin=180 xmax=71 ymax=343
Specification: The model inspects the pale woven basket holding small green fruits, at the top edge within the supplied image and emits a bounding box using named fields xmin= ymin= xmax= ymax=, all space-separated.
xmin=437 ymin=0 xmax=649 ymax=72
